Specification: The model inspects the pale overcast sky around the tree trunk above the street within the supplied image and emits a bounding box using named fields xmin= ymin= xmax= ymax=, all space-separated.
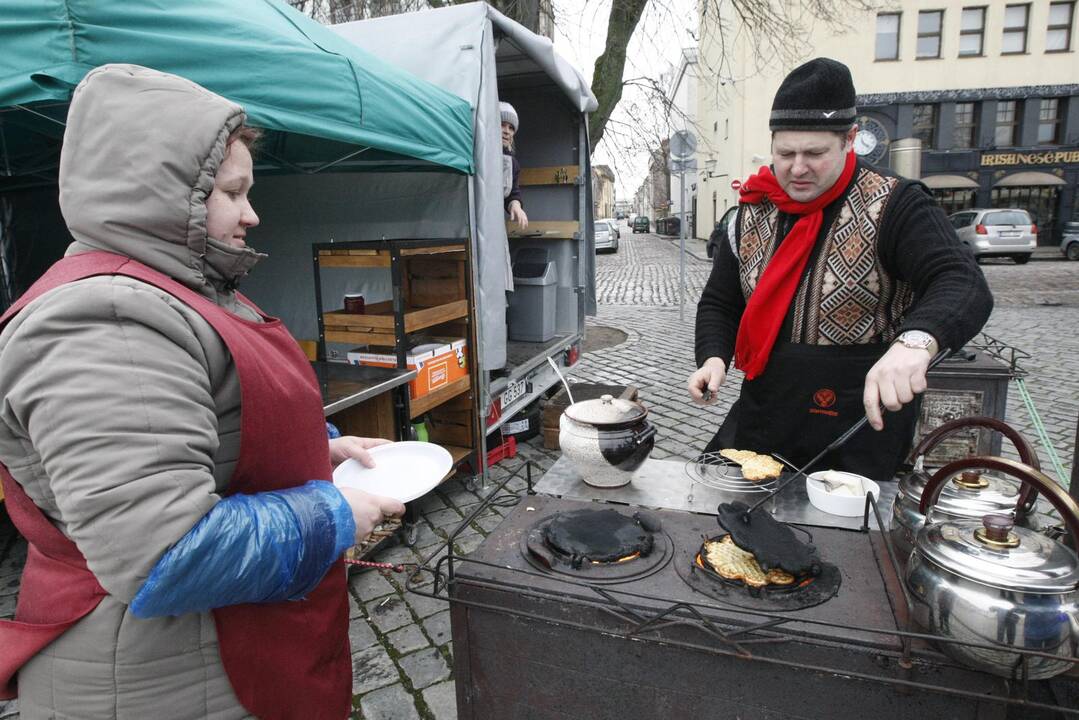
xmin=554 ymin=0 xmax=697 ymax=200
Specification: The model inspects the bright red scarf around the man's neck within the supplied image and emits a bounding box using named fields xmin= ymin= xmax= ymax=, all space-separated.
xmin=735 ymin=152 xmax=857 ymax=380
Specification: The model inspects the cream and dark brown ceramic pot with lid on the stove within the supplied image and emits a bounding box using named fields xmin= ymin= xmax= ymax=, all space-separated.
xmin=558 ymin=395 xmax=656 ymax=488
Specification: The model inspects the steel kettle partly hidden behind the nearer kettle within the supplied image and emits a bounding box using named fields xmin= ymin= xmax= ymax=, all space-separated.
xmin=890 ymin=416 xmax=1041 ymax=562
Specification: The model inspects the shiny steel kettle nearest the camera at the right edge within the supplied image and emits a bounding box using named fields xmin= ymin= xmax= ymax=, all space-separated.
xmin=905 ymin=457 xmax=1079 ymax=679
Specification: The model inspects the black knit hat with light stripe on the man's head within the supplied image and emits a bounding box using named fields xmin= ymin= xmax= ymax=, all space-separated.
xmin=768 ymin=57 xmax=857 ymax=132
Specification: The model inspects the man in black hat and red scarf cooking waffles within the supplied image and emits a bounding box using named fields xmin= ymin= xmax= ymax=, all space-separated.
xmin=687 ymin=57 xmax=993 ymax=480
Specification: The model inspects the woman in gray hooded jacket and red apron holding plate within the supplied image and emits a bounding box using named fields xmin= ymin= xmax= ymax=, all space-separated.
xmin=0 ymin=65 xmax=404 ymax=720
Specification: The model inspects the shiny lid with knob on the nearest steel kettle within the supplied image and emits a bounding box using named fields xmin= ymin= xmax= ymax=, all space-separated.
xmin=916 ymin=515 xmax=1079 ymax=593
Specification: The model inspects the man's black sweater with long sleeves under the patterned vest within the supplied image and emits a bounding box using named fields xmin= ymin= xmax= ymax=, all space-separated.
xmin=694 ymin=171 xmax=993 ymax=369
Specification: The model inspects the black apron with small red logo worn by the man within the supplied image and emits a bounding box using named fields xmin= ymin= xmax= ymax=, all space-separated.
xmin=705 ymin=342 xmax=920 ymax=481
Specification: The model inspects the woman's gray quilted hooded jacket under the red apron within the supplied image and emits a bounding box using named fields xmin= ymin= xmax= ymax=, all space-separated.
xmin=0 ymin=65 xmax=267 ymax=720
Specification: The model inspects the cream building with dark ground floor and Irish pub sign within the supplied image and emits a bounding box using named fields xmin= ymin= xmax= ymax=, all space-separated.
xmin=698 ymin=0 xmax=1079 ymax=245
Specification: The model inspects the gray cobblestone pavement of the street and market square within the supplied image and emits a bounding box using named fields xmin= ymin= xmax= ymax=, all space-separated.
xmin=0 ymin=231 xmax=1079 ymax=720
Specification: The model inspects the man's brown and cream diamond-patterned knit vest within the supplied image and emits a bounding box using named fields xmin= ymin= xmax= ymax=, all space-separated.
xmin=737 ymin=166 xmax=913 ymax=345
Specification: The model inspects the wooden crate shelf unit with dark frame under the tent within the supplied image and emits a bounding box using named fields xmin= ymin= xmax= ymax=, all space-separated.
xmin=313 ymin=239 xmax=482 ymax=481
